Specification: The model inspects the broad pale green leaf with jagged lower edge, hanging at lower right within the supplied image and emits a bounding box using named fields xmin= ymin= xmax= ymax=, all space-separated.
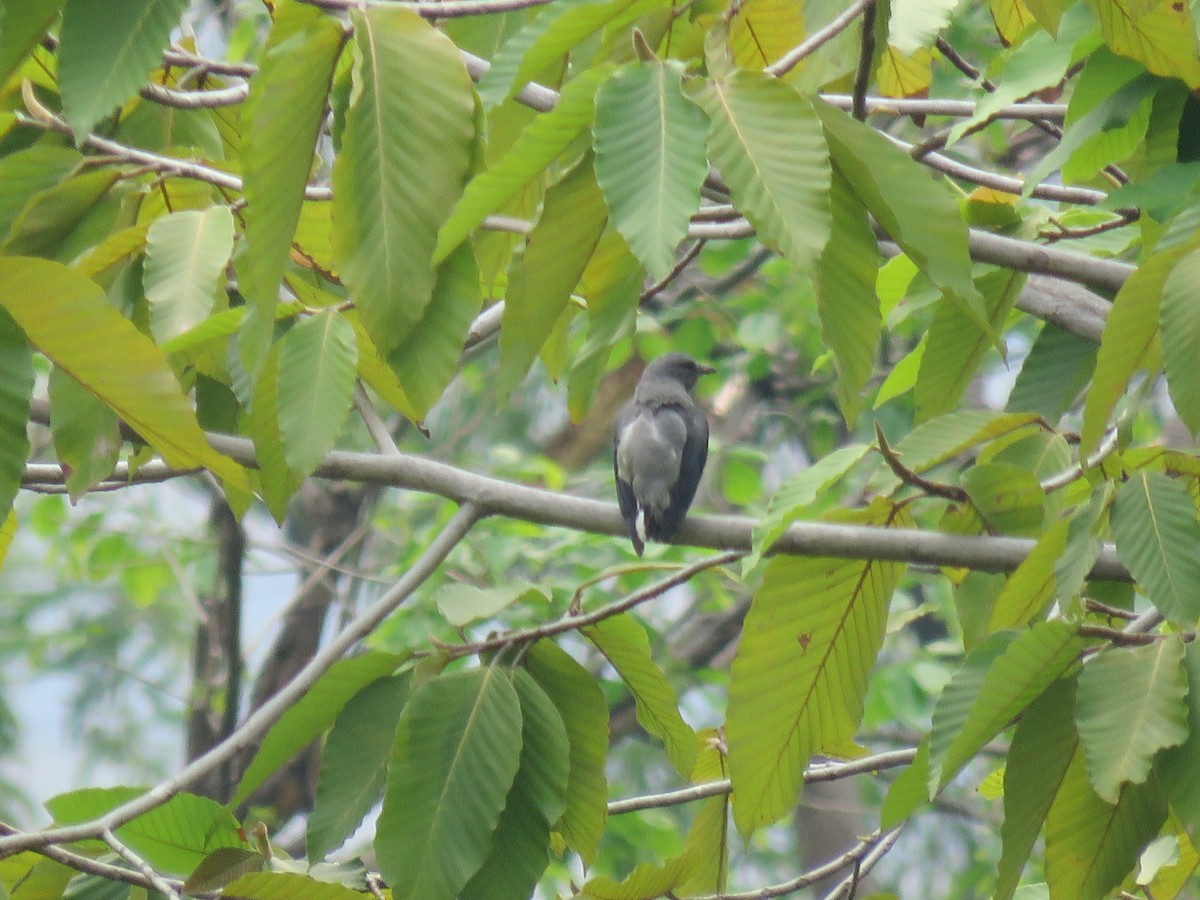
xmin=1075 ymin=637 xmax=1188 ymax=803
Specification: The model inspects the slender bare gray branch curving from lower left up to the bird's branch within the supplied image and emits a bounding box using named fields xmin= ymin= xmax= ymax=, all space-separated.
xmin=0 ymin=503 xmax=480 ymax=859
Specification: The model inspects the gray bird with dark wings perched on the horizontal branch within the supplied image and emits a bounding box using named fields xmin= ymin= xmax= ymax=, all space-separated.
xmin=613 ymin=353 xmax=716 ymax=556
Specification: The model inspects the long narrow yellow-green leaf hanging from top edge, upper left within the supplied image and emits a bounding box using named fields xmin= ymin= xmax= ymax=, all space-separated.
xmin=238 ymin=0 xmax=346 ymax=368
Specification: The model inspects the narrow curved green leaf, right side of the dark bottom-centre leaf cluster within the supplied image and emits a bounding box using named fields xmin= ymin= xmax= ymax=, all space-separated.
xmin=524 ymin=640 xmax=608 ymax=865
